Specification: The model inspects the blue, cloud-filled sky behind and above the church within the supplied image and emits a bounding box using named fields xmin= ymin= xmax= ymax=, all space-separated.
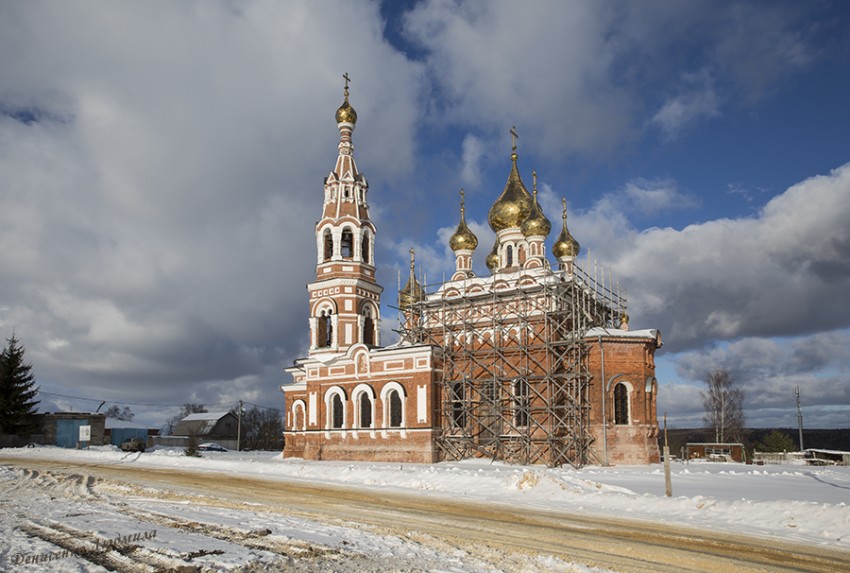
xmin=0 ymin=0 xmax=850 ymax=428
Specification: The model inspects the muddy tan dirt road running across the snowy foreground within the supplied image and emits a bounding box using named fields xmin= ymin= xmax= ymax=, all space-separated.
xmin=0 ymin=458 xmax=850 ymax=573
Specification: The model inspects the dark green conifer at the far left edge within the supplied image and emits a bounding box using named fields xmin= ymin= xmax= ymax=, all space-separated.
xmin=0 ymin=332 xmax=38 ymax=434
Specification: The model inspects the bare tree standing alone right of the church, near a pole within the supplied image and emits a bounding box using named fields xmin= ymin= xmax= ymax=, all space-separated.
xmin=701 ymin=370 xmax=744 ymax=444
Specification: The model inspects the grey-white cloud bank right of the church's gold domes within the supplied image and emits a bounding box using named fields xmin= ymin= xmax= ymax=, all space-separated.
xmin=574 ymin=159 xmax=850 ymax=350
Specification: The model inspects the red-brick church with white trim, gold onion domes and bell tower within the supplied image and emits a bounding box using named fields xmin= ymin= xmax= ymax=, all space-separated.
xmin=281 ymin=78 xmax=661 ymax=467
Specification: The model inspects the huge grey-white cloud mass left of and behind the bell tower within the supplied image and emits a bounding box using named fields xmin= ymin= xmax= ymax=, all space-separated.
xmin=0 ymin=0 xmax=418 ymax=420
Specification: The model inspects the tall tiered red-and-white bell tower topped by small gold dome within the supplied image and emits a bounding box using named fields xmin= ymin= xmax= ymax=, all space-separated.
xmin=307 ymin=74 xmax=383 ymax=356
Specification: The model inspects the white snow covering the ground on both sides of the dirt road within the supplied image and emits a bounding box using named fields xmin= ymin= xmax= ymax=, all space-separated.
xmin=0 ymin=446 xmax=850 ymax=572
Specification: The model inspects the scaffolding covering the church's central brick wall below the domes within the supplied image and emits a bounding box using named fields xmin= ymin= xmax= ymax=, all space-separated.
xmin=400 ymin=265 xmax=626 ymax=467
